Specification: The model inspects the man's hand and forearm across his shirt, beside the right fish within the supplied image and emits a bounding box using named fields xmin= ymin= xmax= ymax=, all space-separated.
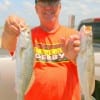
xmin=61 ymin=34 xmax=80 ymax=64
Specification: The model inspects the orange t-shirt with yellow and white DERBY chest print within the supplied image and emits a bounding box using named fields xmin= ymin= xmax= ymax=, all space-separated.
xmin=24 ymin=26 xmax=80 ymax=100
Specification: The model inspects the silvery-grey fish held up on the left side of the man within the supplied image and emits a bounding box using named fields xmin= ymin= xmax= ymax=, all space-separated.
xmin=15 ymin=27 xmax=34 ymax=100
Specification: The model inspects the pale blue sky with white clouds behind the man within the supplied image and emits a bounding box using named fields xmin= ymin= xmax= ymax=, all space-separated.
xmin=0 ymin=0 xmax=100 ymax=27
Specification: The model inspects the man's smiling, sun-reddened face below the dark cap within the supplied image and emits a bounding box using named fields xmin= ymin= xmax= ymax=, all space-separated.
xmin=36 ymin=1 xmax=61 ymax=23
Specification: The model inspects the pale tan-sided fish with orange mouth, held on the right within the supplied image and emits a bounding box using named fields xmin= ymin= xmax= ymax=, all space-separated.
xmin=77 ymin=25 xmax=95 ymax=100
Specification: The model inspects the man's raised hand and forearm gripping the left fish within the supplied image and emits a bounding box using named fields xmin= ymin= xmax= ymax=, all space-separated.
xmin=2 ymin=15 xmax=26 ymax=51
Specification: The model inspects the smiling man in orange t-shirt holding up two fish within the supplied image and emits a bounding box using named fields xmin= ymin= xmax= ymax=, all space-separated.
xmin=2 ymin=0 xmax=80 ymax=100
